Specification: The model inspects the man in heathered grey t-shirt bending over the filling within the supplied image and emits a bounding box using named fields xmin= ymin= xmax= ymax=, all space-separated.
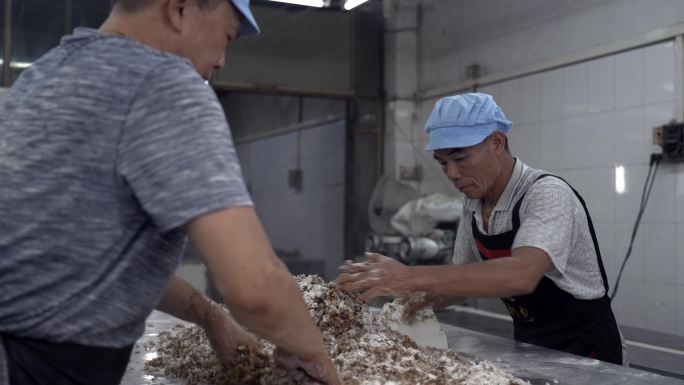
xmin=0 ymin=0 xmax=338 ymax=385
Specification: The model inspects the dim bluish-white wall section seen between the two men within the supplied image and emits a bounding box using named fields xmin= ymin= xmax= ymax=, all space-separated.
xmin=236 ymin=122 xmax=345 ymax=279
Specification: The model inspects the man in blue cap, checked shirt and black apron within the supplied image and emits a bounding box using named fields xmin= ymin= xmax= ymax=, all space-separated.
xmin=339 ymin=93 xmax=623 ymax=364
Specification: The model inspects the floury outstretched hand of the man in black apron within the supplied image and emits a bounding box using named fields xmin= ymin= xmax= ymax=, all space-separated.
xmin=337 ymin=253 xmax=415 ymax=301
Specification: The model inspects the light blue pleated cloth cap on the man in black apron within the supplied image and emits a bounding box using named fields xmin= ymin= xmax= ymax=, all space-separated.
xmin=425 ymin=93 xmax=513 ymax=151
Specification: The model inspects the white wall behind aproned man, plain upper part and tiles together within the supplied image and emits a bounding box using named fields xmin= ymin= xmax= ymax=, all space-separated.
xmin=385 ymin=0 xmax=684 ymax=335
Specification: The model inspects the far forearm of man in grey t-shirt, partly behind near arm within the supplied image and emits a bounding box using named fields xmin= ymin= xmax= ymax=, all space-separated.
xmin=157 ymin=276 xmax=218 ymax=328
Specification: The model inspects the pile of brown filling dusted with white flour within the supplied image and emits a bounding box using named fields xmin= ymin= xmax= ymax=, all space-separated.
xmin=145 ymin=276 xmax=527 ymax=385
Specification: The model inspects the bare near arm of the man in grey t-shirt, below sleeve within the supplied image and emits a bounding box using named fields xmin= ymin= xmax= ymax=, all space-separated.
xmin=188 ymin=207 xmax=326 ymax=357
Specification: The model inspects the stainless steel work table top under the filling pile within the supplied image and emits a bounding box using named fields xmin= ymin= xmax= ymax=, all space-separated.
xmin=122 ymin=311 xmax=684 ymax=385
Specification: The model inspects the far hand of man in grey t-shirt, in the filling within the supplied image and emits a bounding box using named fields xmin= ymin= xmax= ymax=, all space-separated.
xmin=205 ymin=304 xmax=260 ymax=368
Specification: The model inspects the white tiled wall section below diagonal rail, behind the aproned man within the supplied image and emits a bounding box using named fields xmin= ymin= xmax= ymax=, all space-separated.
xmin=432 ymin=42 xmax=684 ymax=335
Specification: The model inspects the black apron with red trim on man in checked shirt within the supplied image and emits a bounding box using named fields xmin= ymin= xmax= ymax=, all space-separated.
xmin=471 ymin=174 xmax=622 ymax=365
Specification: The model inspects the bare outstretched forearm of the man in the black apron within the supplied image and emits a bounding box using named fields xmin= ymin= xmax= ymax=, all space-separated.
xmin=412 ymin=257 xmax=538 ymax=299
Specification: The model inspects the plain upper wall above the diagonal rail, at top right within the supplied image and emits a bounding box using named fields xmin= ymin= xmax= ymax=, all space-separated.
xmin=418 ymin=0 xmax=684 ymax=91
